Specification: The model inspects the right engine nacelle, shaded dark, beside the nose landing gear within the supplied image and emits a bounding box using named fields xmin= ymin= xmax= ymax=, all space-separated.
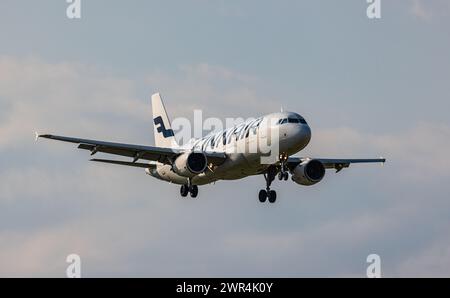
xmin=291 ymin=159 xmax=325 ymax=185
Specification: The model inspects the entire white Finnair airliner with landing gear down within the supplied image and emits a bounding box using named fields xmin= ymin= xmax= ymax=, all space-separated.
xmin=36 ymin=93 xmax=386 ymax=203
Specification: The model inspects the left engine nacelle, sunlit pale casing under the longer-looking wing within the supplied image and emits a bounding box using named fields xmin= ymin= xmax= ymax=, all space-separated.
xmin=172 ymin=152 xmax=208 ymax=177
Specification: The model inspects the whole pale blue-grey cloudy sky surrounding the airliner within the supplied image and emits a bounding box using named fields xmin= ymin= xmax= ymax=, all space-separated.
xmin=0 ymin=0 xmax=450 ymax=277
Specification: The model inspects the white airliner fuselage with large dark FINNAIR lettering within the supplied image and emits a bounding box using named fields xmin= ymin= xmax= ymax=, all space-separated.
xmin=146 ymin=112 xmax=311 ymax=185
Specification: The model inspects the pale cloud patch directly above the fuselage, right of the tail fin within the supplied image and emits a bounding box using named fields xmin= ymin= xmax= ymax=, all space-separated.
xmin=147 ymin=63 xmax=279 ymax=117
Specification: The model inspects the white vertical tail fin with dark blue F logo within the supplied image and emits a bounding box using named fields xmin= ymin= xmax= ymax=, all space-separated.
xmin=152 ymin=93 xmax=178 ymax=148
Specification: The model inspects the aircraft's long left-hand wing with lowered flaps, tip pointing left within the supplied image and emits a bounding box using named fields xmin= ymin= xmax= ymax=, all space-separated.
xmin=36 ymin=134 xmax=226 ymax=166
